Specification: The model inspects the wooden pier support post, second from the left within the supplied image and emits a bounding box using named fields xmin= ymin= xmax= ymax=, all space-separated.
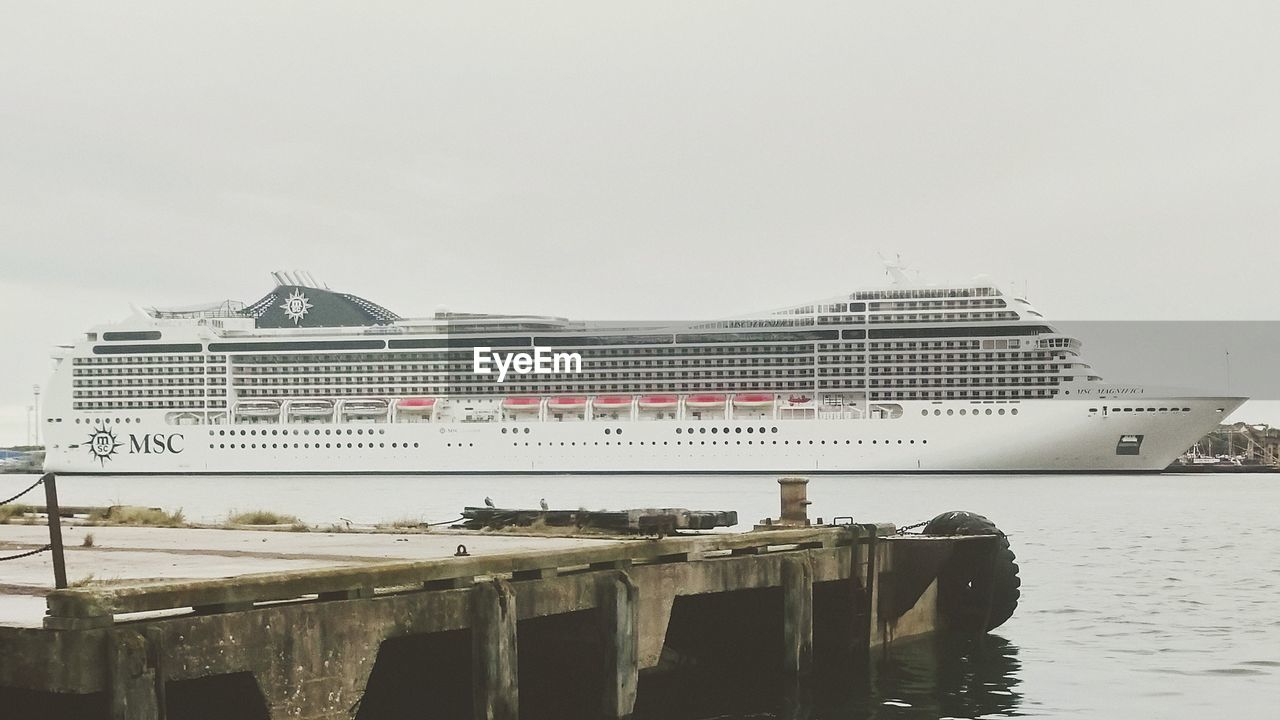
xmin=471 ymin=580 xmax=520 ymax=720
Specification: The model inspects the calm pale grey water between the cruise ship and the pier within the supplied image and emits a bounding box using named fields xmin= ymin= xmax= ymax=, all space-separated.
xmin=0 ymin=475 xmax=1280 ymax=720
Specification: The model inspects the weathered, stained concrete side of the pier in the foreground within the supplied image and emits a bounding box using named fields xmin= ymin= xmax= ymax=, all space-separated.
xmin=0 ymin=517 xmax=993 ymax=720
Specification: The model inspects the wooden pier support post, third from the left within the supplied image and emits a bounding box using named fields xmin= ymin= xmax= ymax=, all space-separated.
xmin=596 ymin=571 xmax=640 ymax=720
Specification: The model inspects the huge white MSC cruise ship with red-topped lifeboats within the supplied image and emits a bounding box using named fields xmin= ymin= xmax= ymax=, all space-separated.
xmin=44 ymin=268 xmax=1244 ymax=475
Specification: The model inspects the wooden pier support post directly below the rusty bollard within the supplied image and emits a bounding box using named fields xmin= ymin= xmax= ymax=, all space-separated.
xmin=782 ymin=552 xmax=813 ymax=717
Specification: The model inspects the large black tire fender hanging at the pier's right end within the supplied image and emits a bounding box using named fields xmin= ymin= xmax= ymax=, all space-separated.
xmin=924 ymin=510 xmax=1023 ymax=633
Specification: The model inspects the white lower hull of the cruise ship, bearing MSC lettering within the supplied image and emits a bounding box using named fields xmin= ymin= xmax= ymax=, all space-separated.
xmin=45 ymin=397 xmax=1243 ymax=475
